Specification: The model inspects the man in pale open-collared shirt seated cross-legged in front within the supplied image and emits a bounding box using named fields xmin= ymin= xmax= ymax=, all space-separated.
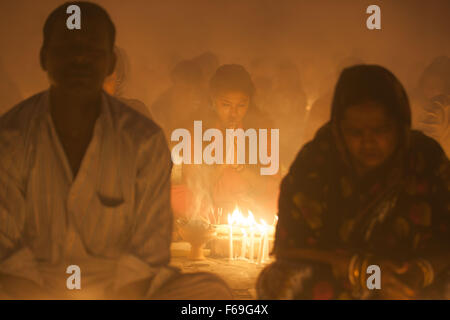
xmin=0 ymin=2 xmax=231 ymax=299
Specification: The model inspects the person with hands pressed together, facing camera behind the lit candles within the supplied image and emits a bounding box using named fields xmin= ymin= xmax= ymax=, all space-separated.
xmin=172 ymin=64 xmax=280 ymax=223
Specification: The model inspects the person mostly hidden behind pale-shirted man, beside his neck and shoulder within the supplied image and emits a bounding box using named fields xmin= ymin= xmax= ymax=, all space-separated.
xmin=103 ymin=46 xmax=152 ymax=119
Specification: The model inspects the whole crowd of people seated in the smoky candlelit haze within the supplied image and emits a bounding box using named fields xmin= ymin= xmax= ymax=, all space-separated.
xmin=0 ymin=2 xmax=450 ymax=299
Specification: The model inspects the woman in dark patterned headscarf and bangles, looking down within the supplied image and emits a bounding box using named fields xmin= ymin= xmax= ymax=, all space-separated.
xmin=257 ymin=65 xmax=450 ymax=299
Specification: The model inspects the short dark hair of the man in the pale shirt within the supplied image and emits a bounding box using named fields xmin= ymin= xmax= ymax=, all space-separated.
xmin=43 ymin=1 xmax=116 ymax=50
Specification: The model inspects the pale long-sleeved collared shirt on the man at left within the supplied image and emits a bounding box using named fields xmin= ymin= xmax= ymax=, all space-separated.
xmin=0 ymin=91 xmax=178 ymax=298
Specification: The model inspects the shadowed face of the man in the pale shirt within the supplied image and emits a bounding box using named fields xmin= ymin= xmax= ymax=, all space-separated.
xmin=42 ymin=16 xmax=115 ymax=95
